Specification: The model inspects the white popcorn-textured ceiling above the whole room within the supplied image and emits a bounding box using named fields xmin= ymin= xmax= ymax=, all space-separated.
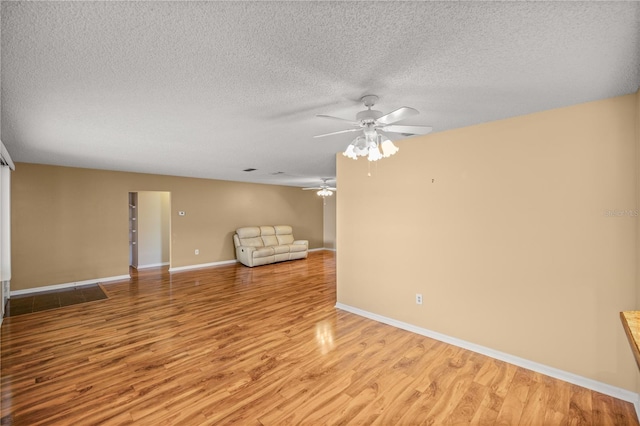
xmin=1 ymin=1 xmax=640 ymax=186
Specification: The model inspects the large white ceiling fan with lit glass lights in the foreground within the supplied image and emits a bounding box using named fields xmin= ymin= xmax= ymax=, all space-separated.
xmin=314 ymin=95 xmax=433 ymax=161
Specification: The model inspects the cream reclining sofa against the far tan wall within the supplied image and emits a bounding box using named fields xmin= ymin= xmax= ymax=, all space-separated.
xmin=233 ymin=225 xmax=309 ymax=267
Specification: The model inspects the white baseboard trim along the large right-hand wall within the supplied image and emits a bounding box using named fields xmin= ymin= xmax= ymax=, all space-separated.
xmin=336 ymin=303 xmax=640 ymax=406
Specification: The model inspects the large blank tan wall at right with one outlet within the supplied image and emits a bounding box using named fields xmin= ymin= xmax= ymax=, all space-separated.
xmin=337 ymin=95 xmax=638 ymax=390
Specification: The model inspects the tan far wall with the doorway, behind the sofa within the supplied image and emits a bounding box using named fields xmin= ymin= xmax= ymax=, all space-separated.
xmin=11 ymin=163 xmax=323 ymax=290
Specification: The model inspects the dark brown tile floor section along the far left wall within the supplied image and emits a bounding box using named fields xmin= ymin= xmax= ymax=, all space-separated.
xmin=5 ymin=284 xmax=107 ymax=317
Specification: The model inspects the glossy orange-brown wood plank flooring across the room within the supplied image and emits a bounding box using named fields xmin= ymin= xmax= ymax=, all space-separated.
xmin=1 ymin=251 xmax=638 ymax=426
